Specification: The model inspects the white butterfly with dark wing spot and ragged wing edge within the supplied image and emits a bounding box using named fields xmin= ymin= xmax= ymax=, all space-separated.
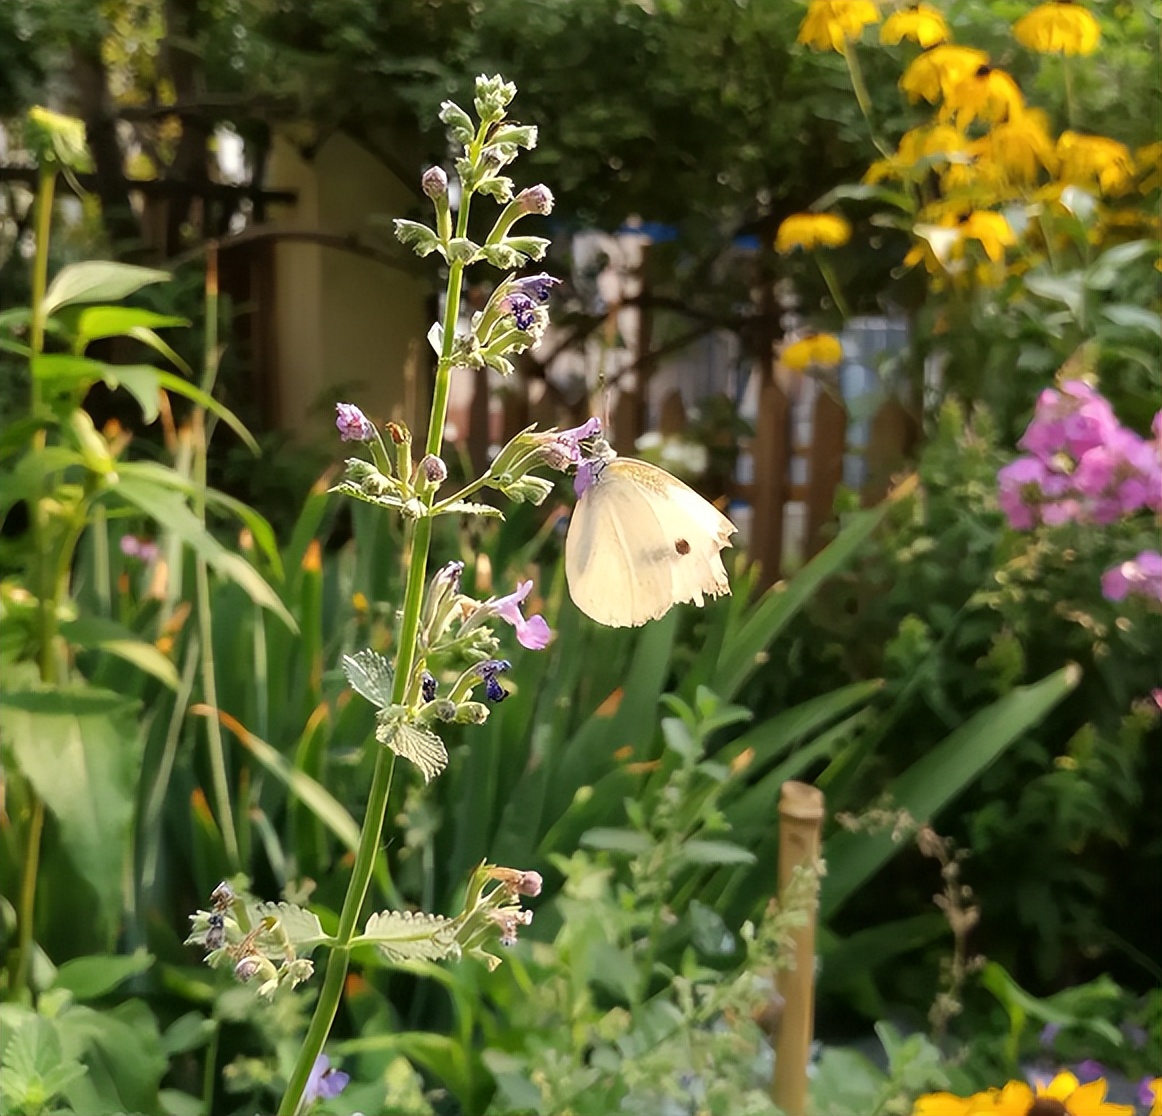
xmin=565 ymin=450 xmax=737 ymax=628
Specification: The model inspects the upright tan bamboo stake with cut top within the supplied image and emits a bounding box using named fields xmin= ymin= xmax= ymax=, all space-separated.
xmin=772 ymin=781 xmax=823 ymax=1116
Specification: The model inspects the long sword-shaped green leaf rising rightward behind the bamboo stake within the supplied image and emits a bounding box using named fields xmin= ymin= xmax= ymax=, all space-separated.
xmin=819 ymin=665 xmax=1081 ymax=920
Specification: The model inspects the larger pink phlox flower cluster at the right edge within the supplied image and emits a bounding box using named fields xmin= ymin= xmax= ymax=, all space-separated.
xmin=997 ymin=380 xmax=1162 ymax=531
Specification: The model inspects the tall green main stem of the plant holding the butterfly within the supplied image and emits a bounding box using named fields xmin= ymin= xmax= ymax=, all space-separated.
xmin=278 ymin=194 xmax=471 ymax=1116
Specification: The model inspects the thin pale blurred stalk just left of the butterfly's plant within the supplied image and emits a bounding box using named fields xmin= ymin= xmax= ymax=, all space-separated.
xmin=193 ymin=242 xmax=242 ymax=872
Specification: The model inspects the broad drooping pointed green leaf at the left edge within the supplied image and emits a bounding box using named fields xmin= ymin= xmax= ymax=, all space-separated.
xmin=0 ymin=687 xmax=142 ymax=924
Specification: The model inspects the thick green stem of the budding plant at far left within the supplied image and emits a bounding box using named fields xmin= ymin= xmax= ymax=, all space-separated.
xmin=9 ymin=166 xmax=57 ymax=999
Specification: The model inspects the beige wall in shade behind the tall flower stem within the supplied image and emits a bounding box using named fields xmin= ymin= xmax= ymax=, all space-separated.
xmin=268 ymin=134 xmax=430 ymax=435
